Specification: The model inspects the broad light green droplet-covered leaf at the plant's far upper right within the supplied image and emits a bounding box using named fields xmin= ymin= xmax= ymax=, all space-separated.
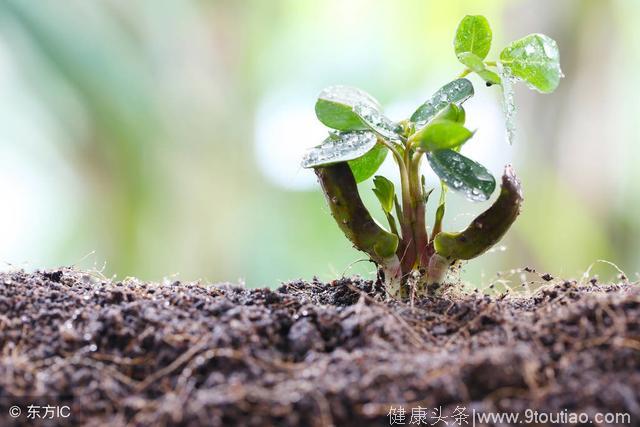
xmin=500 ymin=34 xmax=562 ymax=93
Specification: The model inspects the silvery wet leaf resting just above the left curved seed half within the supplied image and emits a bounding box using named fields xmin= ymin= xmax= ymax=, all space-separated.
xmin=302 ymin=131 xmax=378 ymax=169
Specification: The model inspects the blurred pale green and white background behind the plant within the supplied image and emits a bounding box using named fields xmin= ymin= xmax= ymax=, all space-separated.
xmin=0 ymin=0 xmax=640 ymax=286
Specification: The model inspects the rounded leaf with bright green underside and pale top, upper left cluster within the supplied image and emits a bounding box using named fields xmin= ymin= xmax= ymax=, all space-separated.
xmin=316 ymin=86 xmax=380 ymax=131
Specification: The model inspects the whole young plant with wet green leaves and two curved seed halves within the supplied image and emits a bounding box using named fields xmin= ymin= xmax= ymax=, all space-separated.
xmin=302 ymin=16 xmax=562 ymax=299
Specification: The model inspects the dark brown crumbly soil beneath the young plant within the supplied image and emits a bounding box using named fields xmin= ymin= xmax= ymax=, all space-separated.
xmin=0 ymin=269 xmax=640 ymax=426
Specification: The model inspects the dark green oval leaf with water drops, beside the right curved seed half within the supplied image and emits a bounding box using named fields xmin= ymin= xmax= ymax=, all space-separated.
xmin=427 ymin=150 xmax=496 ymax=202
